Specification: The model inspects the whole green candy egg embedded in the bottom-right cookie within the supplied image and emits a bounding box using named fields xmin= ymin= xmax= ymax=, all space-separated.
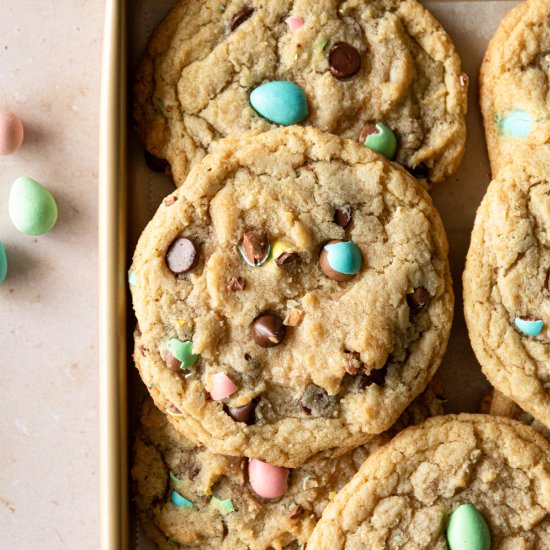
xmin=447 ymin=504 xmax=491 ymax=550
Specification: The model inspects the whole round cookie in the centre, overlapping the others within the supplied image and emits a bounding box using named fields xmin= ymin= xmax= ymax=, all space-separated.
xmin=131 ymin=126 xmax=453 ymax=467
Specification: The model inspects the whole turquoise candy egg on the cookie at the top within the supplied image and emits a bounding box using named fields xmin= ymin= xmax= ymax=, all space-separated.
xmin=250 ymin=80 xmax=309 ymax=126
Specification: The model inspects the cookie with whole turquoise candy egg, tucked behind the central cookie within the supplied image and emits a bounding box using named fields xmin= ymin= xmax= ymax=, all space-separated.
xmin=134 ymin=0 xmax=468 ymax=185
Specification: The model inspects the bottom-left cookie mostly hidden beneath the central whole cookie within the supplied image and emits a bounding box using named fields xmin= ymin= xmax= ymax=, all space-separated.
xmin=132 ymin=386 xmax=443 ymax=550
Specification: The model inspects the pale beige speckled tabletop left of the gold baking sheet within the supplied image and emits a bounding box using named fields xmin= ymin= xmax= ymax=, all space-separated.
xmin=0 ymin=0 xmax=104 ymax=550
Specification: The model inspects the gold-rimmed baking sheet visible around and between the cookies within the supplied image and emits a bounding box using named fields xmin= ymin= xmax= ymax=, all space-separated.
xmin=99 ymin=0 xmax=518 ymax=550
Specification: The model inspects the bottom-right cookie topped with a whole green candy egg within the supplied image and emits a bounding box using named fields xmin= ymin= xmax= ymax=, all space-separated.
xmin=307 ymin=414 xmax=550 ymax=550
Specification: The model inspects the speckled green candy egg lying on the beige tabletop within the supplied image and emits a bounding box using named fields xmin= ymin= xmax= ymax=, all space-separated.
xmin=9 ymin=177 xmax=57 ymax=235
